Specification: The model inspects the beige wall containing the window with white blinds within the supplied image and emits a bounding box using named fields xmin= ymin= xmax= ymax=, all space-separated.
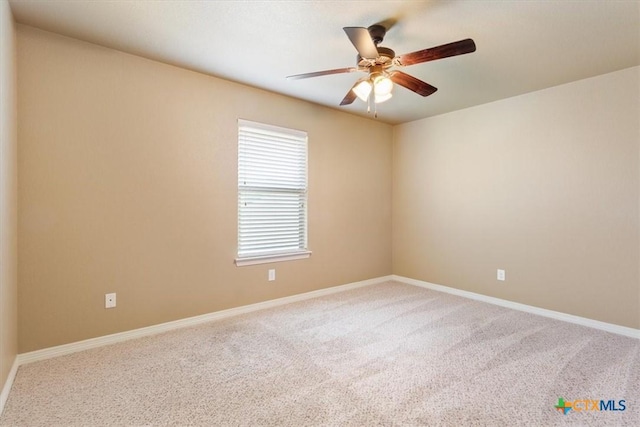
xmin=18 ymin=26 xmax=392 ymax=352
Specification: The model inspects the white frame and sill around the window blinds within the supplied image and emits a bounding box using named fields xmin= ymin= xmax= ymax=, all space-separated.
xmin=235 ymin=119 xmax=311 ymax=267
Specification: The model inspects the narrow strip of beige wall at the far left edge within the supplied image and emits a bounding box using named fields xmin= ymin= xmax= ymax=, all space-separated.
xmin=0 ymin=0 xmax=18 ymax=394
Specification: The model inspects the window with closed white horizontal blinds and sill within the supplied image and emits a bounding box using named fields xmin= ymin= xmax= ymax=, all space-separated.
xmin=236 ymin=120 xmax=311 ymax=266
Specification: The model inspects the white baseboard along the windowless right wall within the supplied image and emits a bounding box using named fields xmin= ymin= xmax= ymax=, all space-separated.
xmin=391 ymin=275 xmax=640 ymax=339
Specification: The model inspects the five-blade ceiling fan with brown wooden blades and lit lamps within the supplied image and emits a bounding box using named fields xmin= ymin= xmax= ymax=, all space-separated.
xmin=287 ymin=24 xmax=476 ymax=105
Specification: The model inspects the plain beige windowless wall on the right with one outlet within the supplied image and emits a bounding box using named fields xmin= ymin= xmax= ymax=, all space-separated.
xmin=392 ymin=67 xmax=640 ymax=328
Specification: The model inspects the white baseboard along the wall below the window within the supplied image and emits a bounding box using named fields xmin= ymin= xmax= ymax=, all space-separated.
xmin=17 ymin=276 xmax=391 ymax=365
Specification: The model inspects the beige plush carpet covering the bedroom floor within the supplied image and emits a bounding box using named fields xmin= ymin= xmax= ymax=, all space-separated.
xmin=0 ymin=282 xmax=640 ymax=426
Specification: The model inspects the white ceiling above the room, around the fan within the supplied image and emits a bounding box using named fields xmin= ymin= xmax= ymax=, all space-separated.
xmin=10 ymin=0 xmax=640 ymax=123
